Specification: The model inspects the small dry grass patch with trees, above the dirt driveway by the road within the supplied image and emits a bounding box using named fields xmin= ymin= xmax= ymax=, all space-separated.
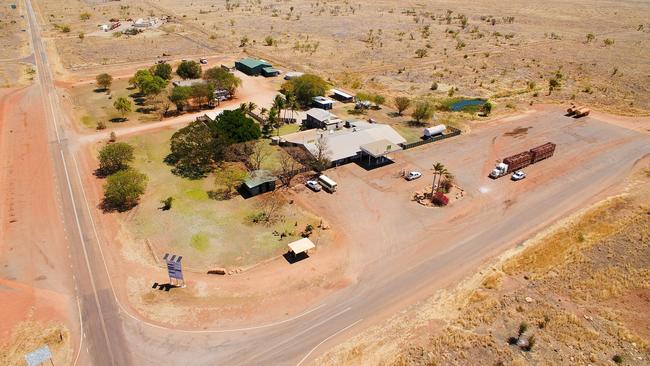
xmin=70 ymin=79 xmax=159 ymax=129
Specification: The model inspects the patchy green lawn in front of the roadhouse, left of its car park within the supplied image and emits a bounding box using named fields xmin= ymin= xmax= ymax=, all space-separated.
xmin=124 ymin=130 xmax=320 ymax=270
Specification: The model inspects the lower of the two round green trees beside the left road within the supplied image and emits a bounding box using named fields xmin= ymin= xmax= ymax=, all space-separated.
xmin=104 ymin=168 xmax=148 ymax=211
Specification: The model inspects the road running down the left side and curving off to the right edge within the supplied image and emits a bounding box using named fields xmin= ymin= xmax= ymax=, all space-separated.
xmin=20 ymin=0 xmax=650 ymax=365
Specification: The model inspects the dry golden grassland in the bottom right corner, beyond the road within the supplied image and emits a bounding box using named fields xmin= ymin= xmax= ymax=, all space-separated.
xmin=319 ymin=172 xmax=650 ymax=365
